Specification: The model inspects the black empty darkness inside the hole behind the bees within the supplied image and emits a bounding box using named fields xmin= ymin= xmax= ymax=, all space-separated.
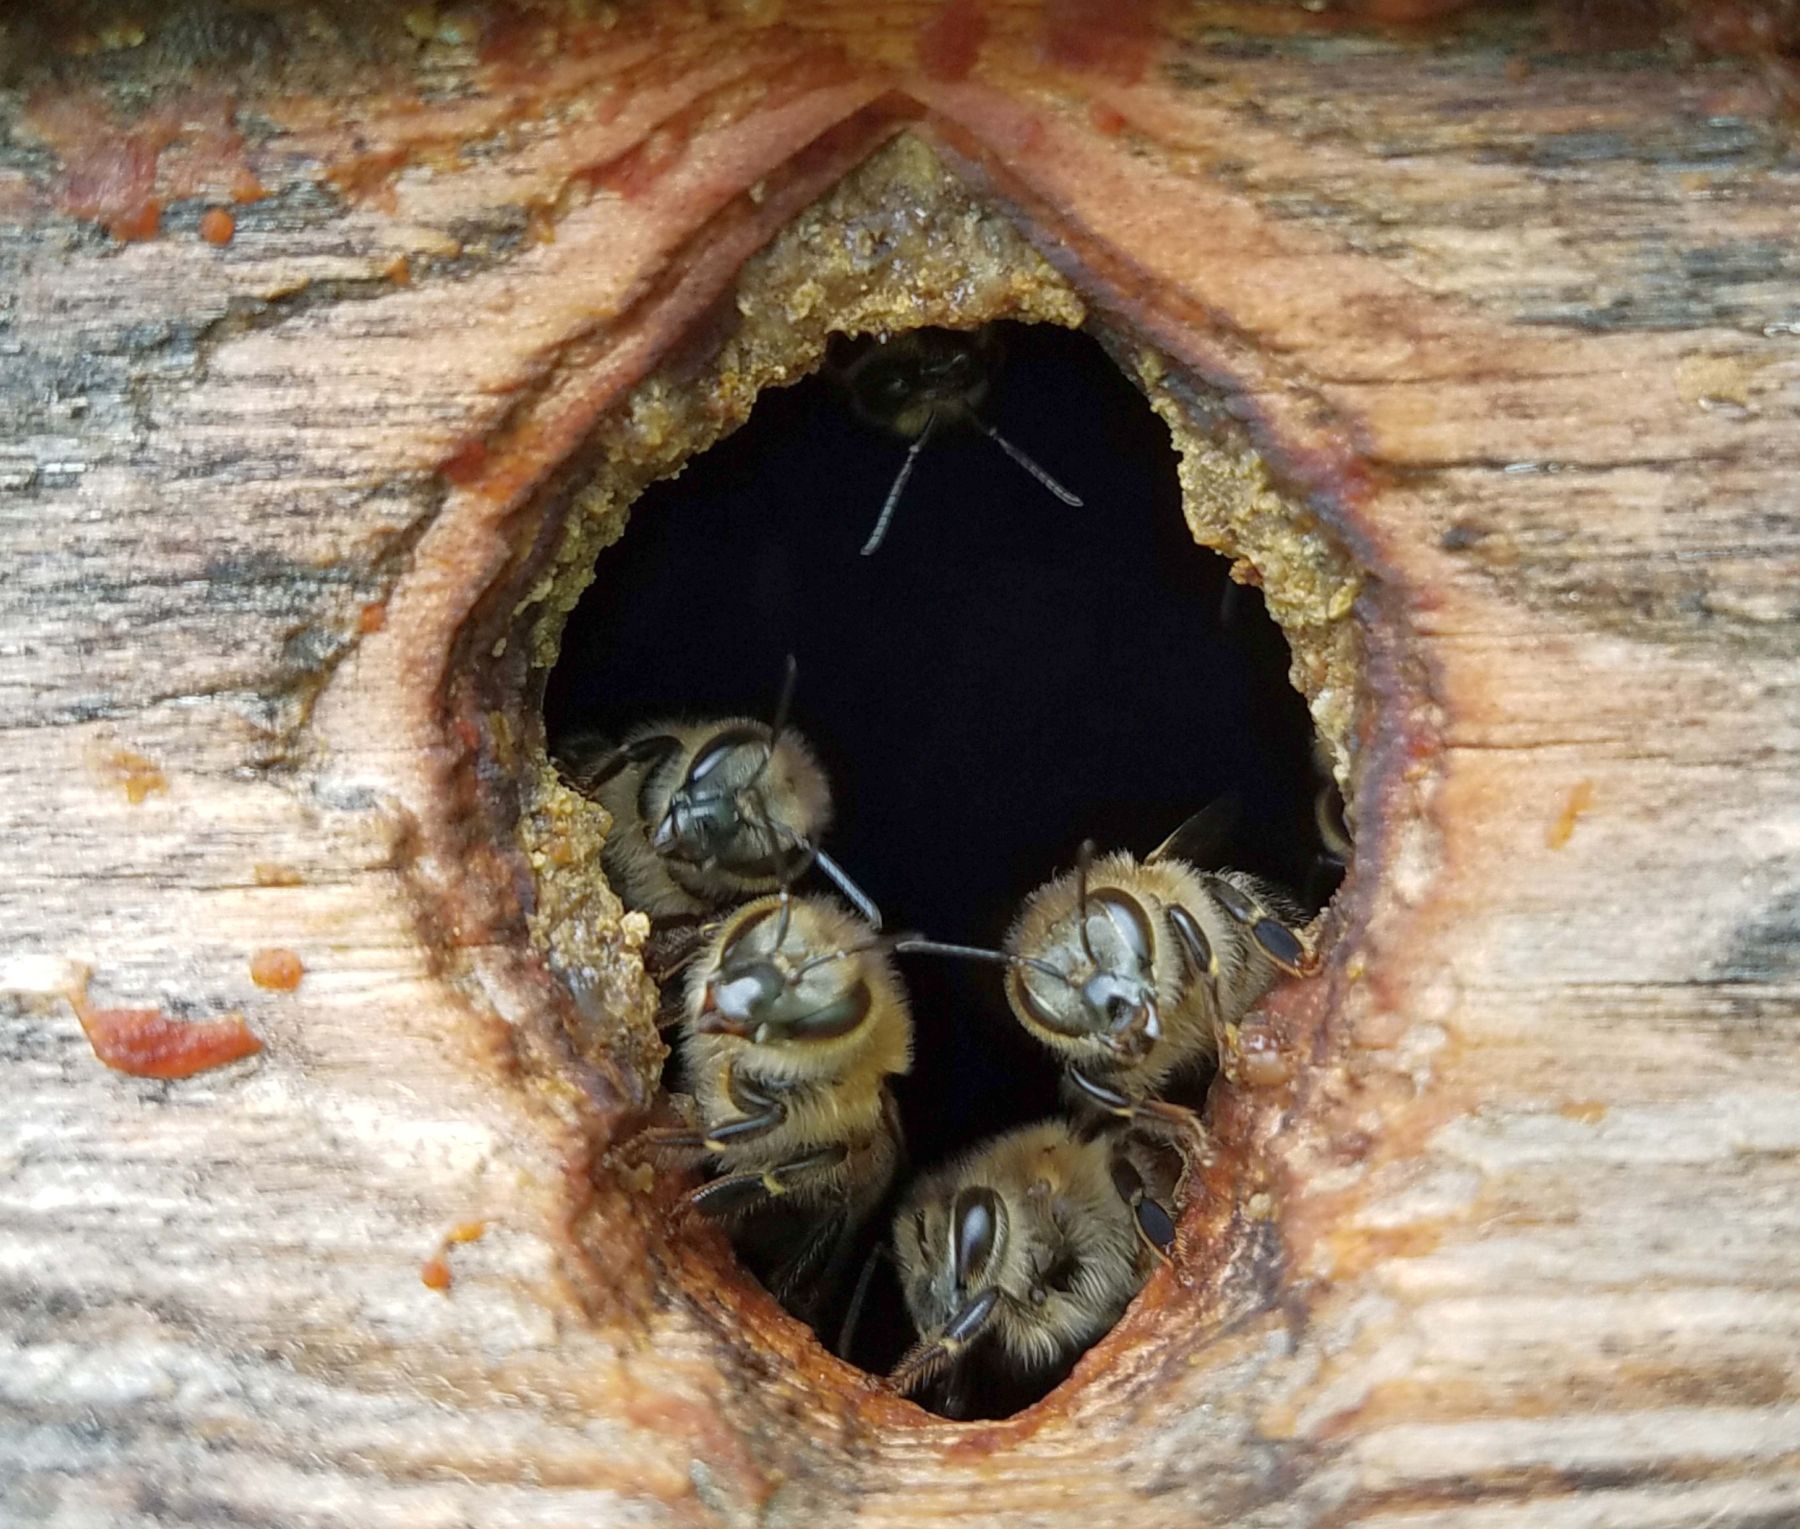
xmin=544 ymin=324 xmax=1336 ymax=1412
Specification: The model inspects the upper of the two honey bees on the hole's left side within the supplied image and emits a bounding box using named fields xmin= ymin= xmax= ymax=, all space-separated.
xmin=560 ymin=657 xmax=880 ymax=927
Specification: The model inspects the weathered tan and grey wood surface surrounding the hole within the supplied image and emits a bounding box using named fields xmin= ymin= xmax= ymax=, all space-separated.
xmin=0 ymin=5 xmax=1800 ymax=1529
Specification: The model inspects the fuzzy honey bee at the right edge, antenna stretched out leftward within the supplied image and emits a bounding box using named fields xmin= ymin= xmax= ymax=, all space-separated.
xmin=895 ymin=812 xmax=1318 ymax=1131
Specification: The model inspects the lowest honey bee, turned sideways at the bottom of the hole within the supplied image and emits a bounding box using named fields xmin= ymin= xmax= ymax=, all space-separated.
xmin=887 ymin=1120 xmax=1175 ymax=1417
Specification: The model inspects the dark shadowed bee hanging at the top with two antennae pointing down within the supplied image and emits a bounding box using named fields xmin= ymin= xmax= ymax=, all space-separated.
xmin=835 ymin=326 xmax=1082 ymax=556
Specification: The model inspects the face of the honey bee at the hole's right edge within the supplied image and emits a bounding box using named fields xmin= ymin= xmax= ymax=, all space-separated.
xmin=1006 ymin=886 xmax=1163 ymax=1061
